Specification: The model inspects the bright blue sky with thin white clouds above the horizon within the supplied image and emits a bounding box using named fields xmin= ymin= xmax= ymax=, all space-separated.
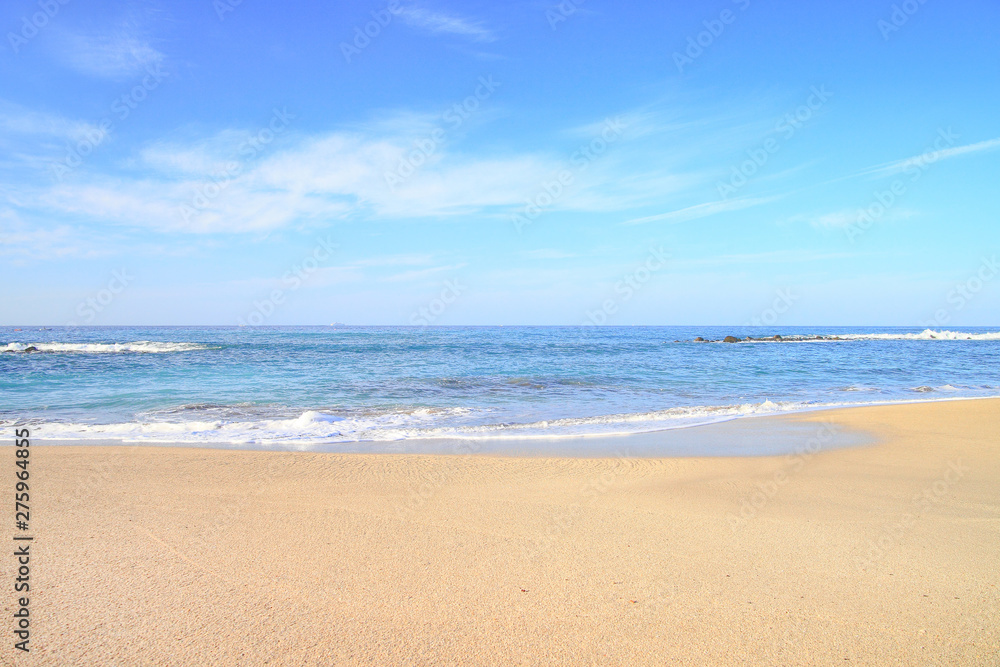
xmin=0 ymin=0 xmax=1000 ymax=330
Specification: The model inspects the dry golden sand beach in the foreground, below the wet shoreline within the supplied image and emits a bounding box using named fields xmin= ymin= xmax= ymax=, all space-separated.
xmin=9 ymin=400 xmax=1000 ymax=665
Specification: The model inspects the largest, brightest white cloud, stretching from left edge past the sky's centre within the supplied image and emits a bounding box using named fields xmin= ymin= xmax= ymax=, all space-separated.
xmin=18 ymin=124 xmax=556 ymax=233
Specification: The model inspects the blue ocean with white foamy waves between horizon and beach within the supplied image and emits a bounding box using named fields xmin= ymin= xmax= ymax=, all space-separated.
xmin=0 ymin=326 xmax=1000 ymax=451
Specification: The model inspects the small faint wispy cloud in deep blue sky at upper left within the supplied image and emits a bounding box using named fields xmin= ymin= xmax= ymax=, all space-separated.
xmin=58 ymin=29 xmax=165 ymax=79
